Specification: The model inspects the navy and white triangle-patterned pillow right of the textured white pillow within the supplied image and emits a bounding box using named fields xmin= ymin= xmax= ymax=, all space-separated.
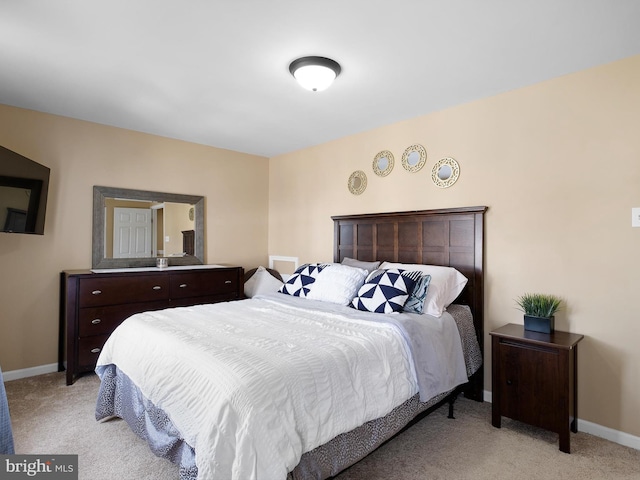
xmin=351 ymin=268 xmax=422 ymax=313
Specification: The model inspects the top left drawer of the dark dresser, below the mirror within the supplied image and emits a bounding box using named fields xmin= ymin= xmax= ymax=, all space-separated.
xmin=78 ymin=275 xmax=169 ymax=308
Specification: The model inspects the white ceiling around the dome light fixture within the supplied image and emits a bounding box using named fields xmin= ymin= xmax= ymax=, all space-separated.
xmin=0 ymin=0 xmax=640 ymax=157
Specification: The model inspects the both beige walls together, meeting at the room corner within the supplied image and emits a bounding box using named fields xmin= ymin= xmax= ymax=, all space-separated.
xmin=0 ymin=56 xmax=640 ymax=436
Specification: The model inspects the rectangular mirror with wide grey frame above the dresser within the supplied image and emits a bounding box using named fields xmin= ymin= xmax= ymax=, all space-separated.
xmin=92 ymin=186 xmax=204 ymax=269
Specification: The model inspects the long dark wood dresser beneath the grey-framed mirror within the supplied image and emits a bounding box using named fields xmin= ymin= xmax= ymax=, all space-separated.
xmin=58 ymin=265 xmax=244 ymax=385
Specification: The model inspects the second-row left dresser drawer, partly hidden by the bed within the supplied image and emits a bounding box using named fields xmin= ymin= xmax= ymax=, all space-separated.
xmin=78 ymin=300 xmax=168 ymax=337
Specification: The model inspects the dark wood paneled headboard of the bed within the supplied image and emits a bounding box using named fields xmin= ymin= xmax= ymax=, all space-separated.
xmin=331 ymin=207 xmax=487 ymax=401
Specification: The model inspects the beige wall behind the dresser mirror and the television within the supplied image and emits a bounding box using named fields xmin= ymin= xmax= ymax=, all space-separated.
xmin=0 ymin=105 xmax=269 ymax=371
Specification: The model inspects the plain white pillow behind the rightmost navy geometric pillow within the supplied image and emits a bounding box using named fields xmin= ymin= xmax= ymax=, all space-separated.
xmin=380 ymin=262 xmax=468 ymax=317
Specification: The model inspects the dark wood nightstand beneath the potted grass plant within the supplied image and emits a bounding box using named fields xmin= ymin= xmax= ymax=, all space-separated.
xmin=490 ymin=323 xmax=584 ymax=453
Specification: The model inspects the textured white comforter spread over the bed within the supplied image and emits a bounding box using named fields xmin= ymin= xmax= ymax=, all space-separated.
xmin=98 ymin=294 xmax=466 ymax=480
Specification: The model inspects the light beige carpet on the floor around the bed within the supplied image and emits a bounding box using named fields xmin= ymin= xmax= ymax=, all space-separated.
xmin=5 ymin=373 xmax=640 ymax=480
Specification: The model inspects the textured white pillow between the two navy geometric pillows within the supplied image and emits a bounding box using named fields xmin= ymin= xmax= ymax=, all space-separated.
xmin=307 ymin=263 xmax=369 ymax=305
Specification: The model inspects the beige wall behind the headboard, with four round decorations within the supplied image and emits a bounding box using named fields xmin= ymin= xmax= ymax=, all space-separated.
xmin=269 ymin=56 xmax=640 ymax=436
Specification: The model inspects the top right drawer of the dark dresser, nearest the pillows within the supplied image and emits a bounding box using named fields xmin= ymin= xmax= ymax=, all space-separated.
xmin=171 ymin=269 xmax=239 ymax=299
